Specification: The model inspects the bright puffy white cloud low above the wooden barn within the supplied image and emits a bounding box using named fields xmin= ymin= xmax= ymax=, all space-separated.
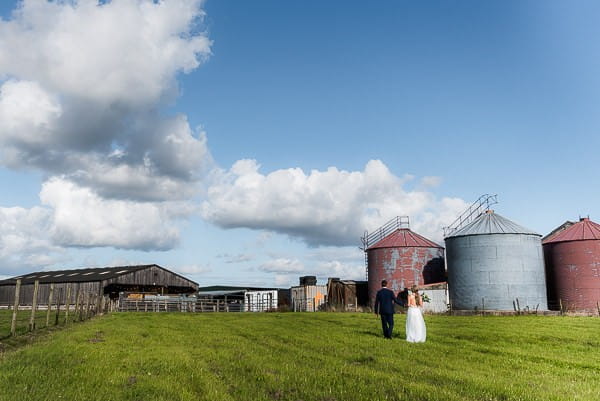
xmin=40 ymin=178 xmax=192 ymax=250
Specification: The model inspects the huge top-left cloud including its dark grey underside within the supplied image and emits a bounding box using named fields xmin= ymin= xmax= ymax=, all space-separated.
xmin=0 ymin=0 xmax=212 ymax=201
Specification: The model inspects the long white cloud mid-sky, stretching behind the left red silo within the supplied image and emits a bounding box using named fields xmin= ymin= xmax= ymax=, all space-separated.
xmin=202 ymin=160 xmax=467 ymax=246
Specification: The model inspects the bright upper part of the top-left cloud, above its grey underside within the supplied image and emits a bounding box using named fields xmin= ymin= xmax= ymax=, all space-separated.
xmin=0 ymin=0 xmax=210 ymax=106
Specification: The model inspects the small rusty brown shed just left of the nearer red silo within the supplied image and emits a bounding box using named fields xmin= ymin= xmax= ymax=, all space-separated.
xmin=327 ymin=278 xmax=369 ymax=311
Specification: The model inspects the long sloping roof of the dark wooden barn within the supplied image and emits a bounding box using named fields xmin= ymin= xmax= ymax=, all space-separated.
xmin=0 ymin=264 xmax=197 ymax=285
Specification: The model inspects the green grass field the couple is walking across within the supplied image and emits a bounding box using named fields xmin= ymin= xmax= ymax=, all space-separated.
xmin=0 ymin=313 xmax=600 ymax=401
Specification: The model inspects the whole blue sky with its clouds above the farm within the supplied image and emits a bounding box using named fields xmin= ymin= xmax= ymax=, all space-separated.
xmin=0 ymin=0 xmax=600 ymax=286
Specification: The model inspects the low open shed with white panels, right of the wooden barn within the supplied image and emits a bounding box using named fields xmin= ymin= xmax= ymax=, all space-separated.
xmin=198 ymin=285 xmax=279 ymax=312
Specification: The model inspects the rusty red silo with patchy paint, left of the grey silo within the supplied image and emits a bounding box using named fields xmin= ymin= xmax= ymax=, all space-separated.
xmin=363 ymin=217 xmax=446 ymax=305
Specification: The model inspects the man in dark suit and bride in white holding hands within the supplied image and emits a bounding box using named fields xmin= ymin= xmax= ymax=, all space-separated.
xmin=375 ymin=280 xmax=427 ymax=343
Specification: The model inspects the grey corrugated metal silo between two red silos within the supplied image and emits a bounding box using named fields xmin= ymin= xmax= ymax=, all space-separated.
xmin=445 ymin=210 xmax=548 ymax=310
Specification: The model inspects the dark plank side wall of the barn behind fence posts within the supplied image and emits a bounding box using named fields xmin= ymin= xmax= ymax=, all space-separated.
xmin=0 ymin=281 xmax=100 ymax=306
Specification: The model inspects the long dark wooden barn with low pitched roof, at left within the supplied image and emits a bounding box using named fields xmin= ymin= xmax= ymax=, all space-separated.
xmin=0 ymin=265 xmax=198 ymax=306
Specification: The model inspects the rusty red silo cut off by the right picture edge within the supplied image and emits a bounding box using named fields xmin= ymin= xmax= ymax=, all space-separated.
xmin=542 ymin=218 xmax=600 ymax=312
